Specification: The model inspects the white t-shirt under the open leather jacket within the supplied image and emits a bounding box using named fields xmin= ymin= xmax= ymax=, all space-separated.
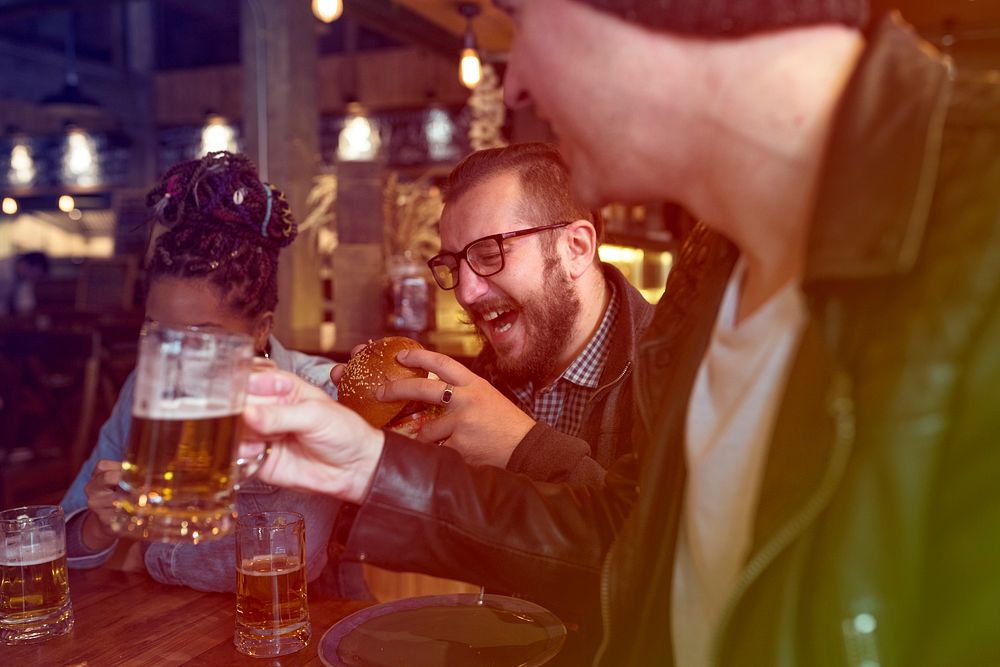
xmin=671 ymin=260 xmax=807 ymax=667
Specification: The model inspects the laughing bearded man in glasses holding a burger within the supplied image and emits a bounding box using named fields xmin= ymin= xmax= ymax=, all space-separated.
xmin=332 ymin=143 xmax=653 ymax=484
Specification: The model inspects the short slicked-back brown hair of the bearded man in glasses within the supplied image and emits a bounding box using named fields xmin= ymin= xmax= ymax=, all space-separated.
xmin=443 ymin=142 xmax=604 ymax=243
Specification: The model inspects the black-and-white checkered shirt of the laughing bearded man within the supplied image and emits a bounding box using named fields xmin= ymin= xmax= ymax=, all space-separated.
xmin=511 ymin=285 xmax=620 ymax=436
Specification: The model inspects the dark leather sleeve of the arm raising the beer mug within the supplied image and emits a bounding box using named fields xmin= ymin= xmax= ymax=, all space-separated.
xmin=345 ymin=434 xmax=636 ymax=616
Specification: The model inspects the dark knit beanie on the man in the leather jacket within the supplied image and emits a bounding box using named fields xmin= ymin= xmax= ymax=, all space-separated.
xmin=576 ymin=0 xmax=868 ymax=37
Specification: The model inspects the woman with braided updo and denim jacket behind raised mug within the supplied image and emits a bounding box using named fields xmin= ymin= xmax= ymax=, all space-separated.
xmin=61 ymin=153 xmax=360 ymax=591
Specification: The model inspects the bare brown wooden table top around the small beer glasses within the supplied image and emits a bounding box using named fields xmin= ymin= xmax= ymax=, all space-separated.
xmin=0 ymin=568 xmax=371 ymax=667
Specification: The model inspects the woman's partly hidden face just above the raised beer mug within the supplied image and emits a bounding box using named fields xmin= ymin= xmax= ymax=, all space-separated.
xmin=146 ymin=278 xmax=270 ymax=350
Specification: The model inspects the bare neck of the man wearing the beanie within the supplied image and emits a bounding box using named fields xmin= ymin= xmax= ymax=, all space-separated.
xmin=690 ymin=27 xmax=863 ymax=322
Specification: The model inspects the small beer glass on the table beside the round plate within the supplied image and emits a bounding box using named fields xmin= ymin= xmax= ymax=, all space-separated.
xmin=233 ymin=512 xmax=312 ymax=657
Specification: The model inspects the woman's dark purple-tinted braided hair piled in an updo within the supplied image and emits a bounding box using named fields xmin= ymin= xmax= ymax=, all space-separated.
xmin=146 ymin=151 xmax=297 ymax=320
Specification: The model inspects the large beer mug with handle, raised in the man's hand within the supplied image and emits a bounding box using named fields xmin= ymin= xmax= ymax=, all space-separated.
xmin=112 ymin=324 xmax=262 ymax=543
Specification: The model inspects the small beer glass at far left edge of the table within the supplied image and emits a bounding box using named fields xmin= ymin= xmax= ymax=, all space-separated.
xmin=0 ymin=505 xmax=73 ymax=644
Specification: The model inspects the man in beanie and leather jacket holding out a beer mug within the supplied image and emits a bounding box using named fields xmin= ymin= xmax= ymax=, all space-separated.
xmin=247 ymin=0 xmax=1000 ymax=666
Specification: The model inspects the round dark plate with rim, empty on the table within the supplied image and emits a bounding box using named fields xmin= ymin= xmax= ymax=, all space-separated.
xmin=319 ymin=593 xmax=566 ymax=667
